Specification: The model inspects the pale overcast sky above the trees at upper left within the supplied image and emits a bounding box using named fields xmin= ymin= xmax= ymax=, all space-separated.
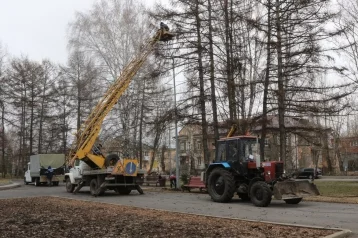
xmin=0 ymin=0 xmax=161 ymax=64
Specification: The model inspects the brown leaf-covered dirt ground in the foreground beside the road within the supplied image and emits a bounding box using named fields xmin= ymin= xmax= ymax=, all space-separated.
xmin=0 ymin=197 xmax=333 ymax=238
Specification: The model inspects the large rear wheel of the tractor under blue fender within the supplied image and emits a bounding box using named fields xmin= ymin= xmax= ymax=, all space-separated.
xmin=208 ymin=168 xmax=236 ymax=202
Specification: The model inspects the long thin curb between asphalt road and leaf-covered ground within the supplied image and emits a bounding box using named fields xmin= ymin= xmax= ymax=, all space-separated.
xmin=49 ymin=195 xmax=352 ymax=238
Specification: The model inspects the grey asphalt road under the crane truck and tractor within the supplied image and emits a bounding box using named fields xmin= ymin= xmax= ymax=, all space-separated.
xmin=0 ymin=184 xmax=358 ymax=237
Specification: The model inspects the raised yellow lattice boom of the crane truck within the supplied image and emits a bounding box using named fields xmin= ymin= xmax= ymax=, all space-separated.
xmin=68 ymin=28 xmax=173 ymax=168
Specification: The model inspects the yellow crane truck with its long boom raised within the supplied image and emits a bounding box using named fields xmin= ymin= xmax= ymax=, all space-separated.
xmin=64 ymin=23 xmax=174 ymax=196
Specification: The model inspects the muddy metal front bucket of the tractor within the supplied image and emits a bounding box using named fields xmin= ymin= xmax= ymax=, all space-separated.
xmin=273 ymin=180 xmax=320 ymax=199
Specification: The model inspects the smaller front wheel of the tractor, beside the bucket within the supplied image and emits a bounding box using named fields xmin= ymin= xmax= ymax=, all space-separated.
xmin=250 ymin=181 xmax=272 ymax=207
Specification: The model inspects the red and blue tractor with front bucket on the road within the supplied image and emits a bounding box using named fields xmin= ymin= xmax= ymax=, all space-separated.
xmin=204 ymin=136 xmax=319 ymax=207
